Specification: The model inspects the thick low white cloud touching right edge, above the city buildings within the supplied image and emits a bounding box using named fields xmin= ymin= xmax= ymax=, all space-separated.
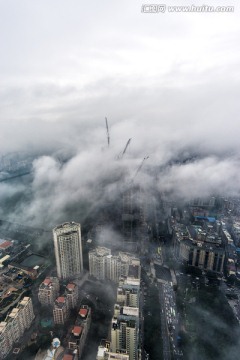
xmin=158 ymin=157 xmax=240 ymax=201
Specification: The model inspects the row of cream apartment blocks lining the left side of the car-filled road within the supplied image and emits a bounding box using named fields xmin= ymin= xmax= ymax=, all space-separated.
xmin=94 ymin=248 xmax=141 ymax=360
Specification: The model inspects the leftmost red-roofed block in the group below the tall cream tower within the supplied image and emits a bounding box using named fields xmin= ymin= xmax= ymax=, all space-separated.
xmin=38 ymin=277 xmax=59 ymax=306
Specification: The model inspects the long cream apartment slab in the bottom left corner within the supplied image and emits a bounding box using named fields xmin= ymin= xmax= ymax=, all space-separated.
xmin=0 ymin=296 xmax=34 ymax=359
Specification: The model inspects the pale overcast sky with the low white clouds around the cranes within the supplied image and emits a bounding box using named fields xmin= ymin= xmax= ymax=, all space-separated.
xmin=0 ymin=0 xmax=240 ymax=224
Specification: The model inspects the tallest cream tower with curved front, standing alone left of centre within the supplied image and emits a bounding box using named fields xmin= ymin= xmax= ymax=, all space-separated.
xmin=53 ymin=222 xmax=83 ymax=279
